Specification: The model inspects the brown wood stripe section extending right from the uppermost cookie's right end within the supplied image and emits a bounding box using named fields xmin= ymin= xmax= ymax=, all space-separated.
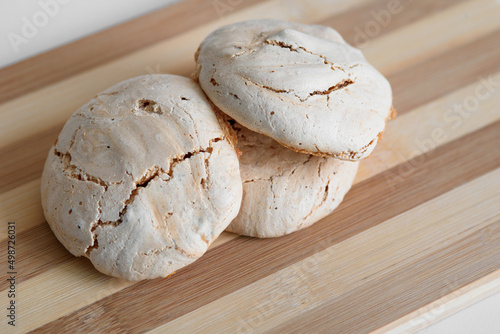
xmin=387 ymin=30 xmax=500 ymax=114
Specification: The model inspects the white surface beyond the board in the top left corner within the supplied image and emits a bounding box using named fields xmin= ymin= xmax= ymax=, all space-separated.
xmin=0 ymin=0 xmax=180 ymax=67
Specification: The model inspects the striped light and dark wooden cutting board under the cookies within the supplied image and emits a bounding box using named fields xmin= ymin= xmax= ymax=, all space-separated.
xmin=0 ymin=0 xmax=500 ymax=333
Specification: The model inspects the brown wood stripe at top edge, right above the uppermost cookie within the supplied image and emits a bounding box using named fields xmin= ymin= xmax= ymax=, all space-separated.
xmin=320 ymin=0 xmax=468 ymax=47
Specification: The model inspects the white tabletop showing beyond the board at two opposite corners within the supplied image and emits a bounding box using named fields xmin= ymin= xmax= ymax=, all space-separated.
xmin=0 ymin=0 xmax=500 ymax=334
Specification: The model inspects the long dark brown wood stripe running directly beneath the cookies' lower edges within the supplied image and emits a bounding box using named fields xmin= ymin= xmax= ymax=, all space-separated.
xmin=29 ymin=122 xmax=500 ymax=333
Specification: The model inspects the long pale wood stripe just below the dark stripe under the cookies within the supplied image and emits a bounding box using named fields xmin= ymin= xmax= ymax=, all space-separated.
xmin=150 ymin=169 xmax=500 ymax=333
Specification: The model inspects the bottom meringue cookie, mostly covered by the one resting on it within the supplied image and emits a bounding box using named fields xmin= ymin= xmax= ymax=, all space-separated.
xmin=226 ymin=123 xmax=359 ymax=238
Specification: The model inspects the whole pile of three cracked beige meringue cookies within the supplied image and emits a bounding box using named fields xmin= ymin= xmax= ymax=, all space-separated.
xmin=41 ymin=20 xmax=394 ymax=281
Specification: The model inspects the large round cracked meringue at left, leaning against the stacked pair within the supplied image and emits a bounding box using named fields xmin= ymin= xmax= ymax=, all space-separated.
xmin=41 ymin=75 xmax=242 ymax=280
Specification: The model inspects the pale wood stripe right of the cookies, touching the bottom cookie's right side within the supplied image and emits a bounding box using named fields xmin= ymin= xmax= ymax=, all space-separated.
xmin=356 ymin=72 xmax=500 ymax=180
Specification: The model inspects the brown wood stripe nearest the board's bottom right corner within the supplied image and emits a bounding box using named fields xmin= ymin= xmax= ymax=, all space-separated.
xmin=269 ymin=218 xmax=500 ymax=333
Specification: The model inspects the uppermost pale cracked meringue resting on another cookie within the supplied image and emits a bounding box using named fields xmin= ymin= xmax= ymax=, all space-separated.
xmin=194 ymin=20 xmax=392 ymax=160
